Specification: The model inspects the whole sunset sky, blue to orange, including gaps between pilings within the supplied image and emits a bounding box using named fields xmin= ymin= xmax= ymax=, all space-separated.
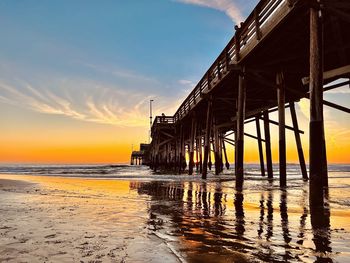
xmin=0 ymin=0 xmax=350 ymax=163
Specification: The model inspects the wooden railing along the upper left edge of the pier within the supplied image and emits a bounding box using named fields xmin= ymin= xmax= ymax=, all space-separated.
xmin=174 ymin=0 xmax=299 ymax=123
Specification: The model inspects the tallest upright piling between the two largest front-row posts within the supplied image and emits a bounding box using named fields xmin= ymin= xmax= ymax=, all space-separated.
xmin=276 ymin=72 xmax=287 ymax=187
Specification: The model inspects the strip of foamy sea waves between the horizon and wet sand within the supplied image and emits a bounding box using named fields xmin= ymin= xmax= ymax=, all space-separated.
xmin=0 ymin=164 xmax=350 ymax=180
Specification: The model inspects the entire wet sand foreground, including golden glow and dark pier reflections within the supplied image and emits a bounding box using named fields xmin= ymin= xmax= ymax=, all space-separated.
xmin=0 ymin=175 xmax=350 ymax=262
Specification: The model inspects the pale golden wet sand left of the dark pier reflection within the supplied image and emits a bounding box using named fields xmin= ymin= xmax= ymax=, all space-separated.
xmin=0 ymin=175 xmax=179 ymax=262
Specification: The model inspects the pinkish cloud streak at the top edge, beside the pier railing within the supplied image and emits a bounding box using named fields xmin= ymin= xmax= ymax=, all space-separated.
xmin=177 ymin=0 xmax=244 ymax=24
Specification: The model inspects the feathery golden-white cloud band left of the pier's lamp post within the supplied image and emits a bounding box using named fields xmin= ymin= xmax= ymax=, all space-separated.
xmin=0 ymin=77 xmax=171 ymax=127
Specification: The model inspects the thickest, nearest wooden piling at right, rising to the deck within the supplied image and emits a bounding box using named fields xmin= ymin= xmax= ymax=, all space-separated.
xmin=310 ymin=1 xmax=328 ymax=207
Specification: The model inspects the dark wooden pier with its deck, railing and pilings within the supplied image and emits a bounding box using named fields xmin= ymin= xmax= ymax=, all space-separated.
xmin=142 ymin=0 xmax=350 ymax=207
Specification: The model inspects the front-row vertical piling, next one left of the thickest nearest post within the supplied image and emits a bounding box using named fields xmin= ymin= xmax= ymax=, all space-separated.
xmin=235 ymin=70 xmax=246 ymax=189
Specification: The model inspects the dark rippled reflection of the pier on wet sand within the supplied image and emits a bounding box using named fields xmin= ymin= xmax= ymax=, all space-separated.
xmin=130 ymin=182 xmax=332 ymax=262
